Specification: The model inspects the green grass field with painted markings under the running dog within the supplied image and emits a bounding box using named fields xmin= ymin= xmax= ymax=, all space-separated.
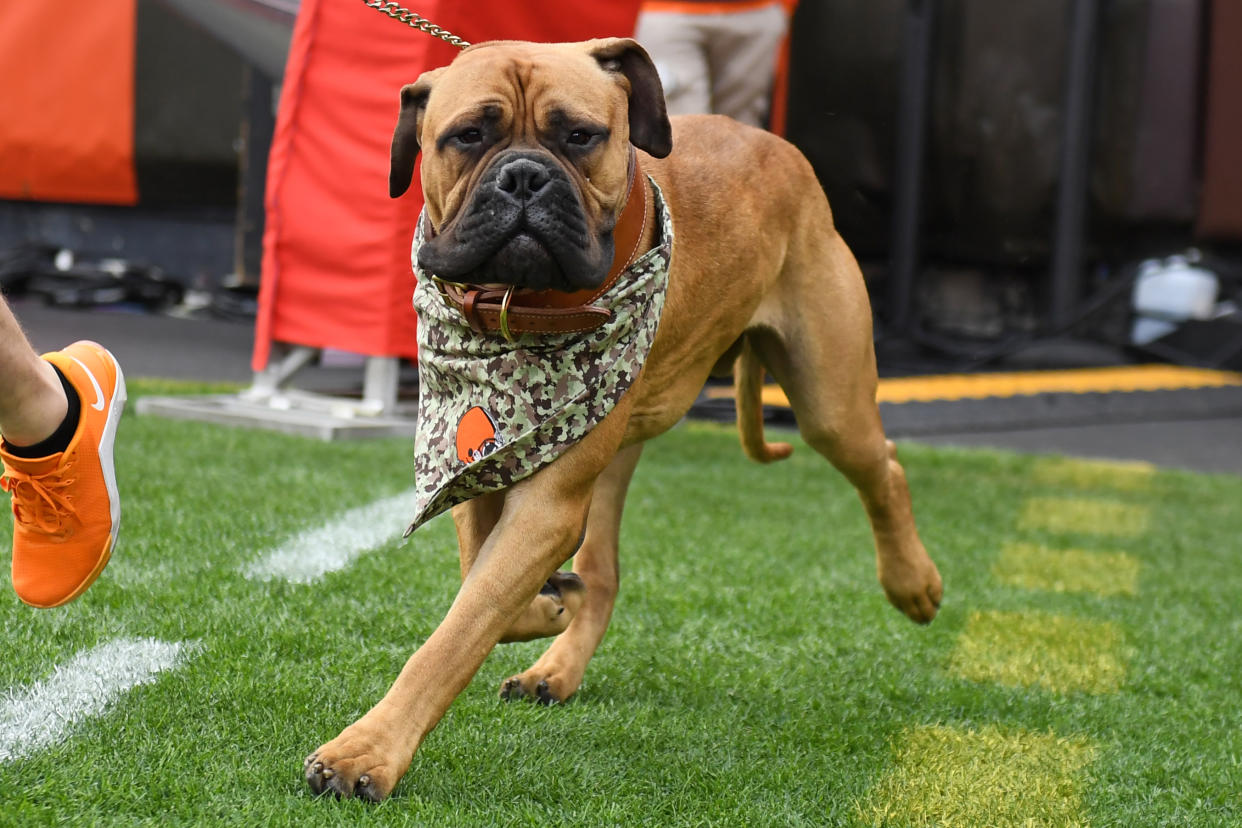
xmin=0 ymin=382 xmax=1242 ymax=827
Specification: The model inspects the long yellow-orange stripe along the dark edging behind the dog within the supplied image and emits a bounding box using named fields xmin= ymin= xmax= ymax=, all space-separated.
xmin=707 ymin=365 xmax=1242 ymax=407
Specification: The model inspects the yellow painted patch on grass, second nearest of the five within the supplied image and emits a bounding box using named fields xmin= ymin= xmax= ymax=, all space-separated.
xmin=949 ymin=612 xmax=1125 ymax=693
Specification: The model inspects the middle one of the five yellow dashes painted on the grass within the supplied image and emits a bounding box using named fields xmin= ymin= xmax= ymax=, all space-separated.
xmin=992 ymin=544 xmax=1139 ymax=596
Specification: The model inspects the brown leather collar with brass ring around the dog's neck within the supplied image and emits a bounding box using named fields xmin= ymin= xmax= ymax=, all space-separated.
xmin=431 ymin=146 xmax=651 ymax=341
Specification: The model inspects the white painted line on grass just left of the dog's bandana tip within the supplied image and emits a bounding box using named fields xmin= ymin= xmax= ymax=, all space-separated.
xmin=242 ymin=490 xmax=414 ymax=583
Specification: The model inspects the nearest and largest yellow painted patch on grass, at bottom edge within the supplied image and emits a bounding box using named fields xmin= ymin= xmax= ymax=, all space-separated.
xmin=857 ymin=726 xmax=1097 ymax=828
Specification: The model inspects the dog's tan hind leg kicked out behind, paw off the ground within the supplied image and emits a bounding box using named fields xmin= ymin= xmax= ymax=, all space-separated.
xmin=749 ymin=227 xmax=943 ymax=623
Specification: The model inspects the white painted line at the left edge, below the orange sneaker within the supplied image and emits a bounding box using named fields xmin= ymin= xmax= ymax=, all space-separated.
xmin=0 ymin=638 xmax=196 ymax=762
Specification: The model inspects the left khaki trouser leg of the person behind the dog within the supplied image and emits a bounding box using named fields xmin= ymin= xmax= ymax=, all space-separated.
xmin=633 ymin=10 xmax=712 ymax=115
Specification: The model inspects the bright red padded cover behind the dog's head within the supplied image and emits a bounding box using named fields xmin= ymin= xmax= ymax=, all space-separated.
xmin=252 ymin=0 xmax=638 ymax=371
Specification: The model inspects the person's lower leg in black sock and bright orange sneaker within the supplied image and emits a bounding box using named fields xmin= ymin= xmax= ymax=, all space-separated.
xmin=0 ymin=299 xmax=125 ymax=607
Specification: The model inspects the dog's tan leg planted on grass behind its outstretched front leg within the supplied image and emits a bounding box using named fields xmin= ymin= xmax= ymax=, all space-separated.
xmin=501 ymin=443 xmax=642 ymax=704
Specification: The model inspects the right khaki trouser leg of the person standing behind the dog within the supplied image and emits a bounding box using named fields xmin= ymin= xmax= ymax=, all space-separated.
xmin=703 ymin=0 xmax=789 ymax=128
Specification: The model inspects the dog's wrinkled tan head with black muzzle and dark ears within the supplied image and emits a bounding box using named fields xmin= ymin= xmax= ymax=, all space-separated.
xmin=389 ymin=38 xmax=672 ymax=290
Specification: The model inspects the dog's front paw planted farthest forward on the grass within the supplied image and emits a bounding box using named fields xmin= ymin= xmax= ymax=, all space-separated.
xmin=302 ymin=724 xmax=411 ymax=802
